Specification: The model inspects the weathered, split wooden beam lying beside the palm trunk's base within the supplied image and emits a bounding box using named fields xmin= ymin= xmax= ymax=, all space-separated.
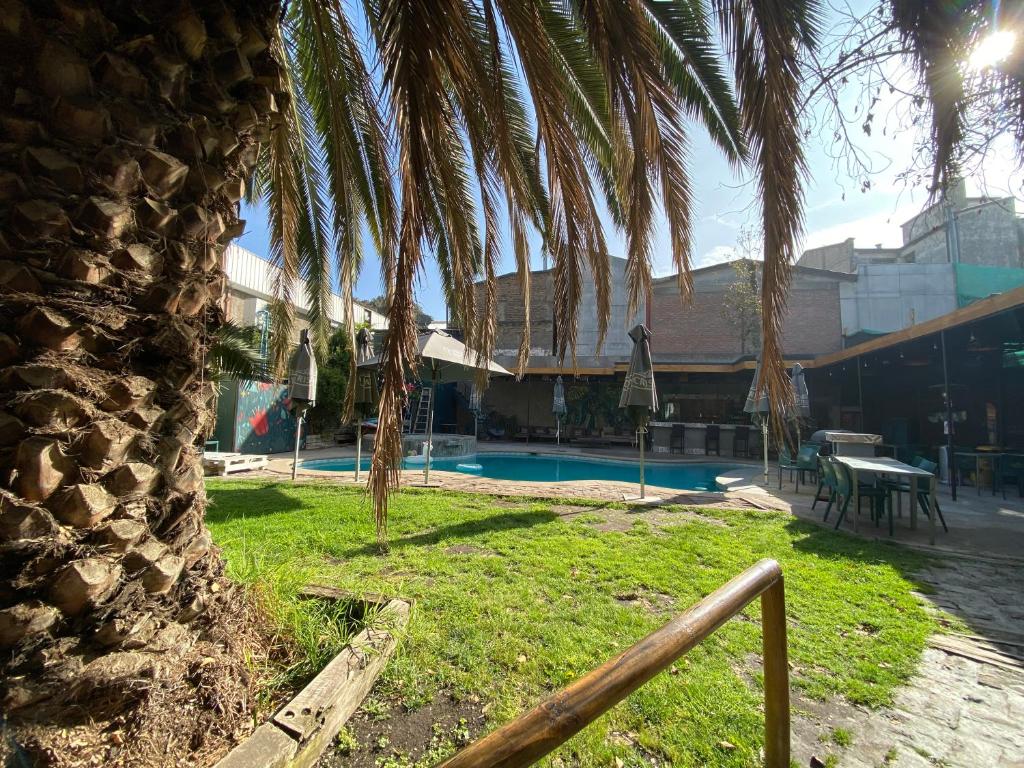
xmin=215 ymin=600 xmax=411 ymax=768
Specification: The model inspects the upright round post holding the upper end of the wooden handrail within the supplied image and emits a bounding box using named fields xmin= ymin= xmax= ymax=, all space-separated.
xmin=761 ymin=574 xmax=790 ymax=768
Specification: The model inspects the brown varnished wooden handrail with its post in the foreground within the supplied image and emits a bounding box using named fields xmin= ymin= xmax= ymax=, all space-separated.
xmin=441 ymin=560 xmax=790 ymax=768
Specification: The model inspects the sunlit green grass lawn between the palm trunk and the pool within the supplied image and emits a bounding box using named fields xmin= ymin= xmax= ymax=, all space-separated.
xmin=208 ymin=480 xmax=937 ymax=766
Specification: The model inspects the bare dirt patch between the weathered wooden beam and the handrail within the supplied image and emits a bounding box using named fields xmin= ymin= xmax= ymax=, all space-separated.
xmin=316 ymin=692 xmax=485 ymax=768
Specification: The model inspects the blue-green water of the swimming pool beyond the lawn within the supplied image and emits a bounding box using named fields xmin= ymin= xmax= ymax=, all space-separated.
xmin=302 ymin=454 xmax=732 ymax=490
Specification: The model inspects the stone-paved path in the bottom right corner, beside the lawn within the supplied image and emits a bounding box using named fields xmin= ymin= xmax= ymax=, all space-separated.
xmin=794 ymin=558 xmax=1024 ymax=768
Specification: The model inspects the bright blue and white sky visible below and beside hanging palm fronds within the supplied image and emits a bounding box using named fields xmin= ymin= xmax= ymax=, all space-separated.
xmin=238 ymin=0 xmax=1022 ymax=318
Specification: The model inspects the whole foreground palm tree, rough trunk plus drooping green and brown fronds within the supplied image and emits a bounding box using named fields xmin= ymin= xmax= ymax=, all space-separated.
xmin=0 ymin=0 xmax=1007 ymax=763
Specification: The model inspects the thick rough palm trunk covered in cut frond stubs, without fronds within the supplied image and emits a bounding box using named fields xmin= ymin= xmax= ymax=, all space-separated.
xmin=0 ymin=0 xmax=283 ymax=764
